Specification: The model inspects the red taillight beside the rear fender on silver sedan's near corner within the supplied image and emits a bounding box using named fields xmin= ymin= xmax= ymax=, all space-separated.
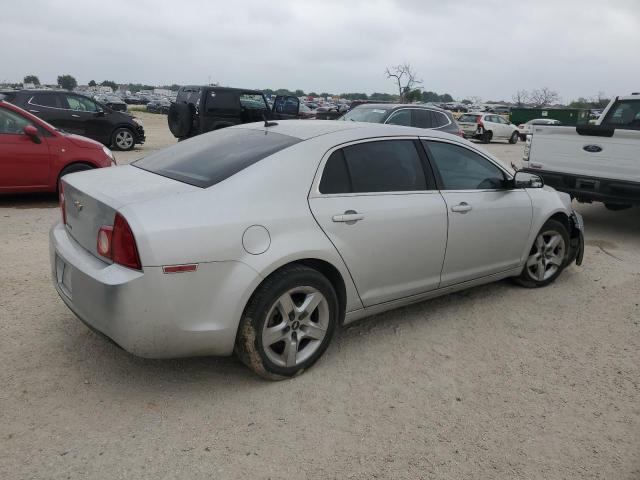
xmin=97 ymin=213 xmax=142 ymax=270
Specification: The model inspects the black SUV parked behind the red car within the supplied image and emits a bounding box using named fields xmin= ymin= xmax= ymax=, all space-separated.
xmin=0 ymin=90 xmax=145 ymax=150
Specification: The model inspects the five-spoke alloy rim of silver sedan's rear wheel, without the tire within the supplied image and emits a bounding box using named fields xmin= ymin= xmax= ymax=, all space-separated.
xmin=262 ymin=286 xmax=329 ymax=368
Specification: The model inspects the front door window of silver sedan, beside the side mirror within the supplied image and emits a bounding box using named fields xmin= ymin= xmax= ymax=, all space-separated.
xmin=425 ymin=142 xmax=504 ymax=190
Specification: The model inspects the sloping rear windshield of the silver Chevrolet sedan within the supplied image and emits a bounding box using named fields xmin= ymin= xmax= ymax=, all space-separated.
xmin=132 ymin=128 xmax=301 ymax=188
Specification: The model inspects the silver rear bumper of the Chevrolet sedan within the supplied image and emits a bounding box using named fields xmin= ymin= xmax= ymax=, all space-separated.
xmin=50 ymin=224 xmax=260 ymax=358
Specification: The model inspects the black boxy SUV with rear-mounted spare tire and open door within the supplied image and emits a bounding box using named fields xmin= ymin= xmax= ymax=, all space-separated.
xmin=167 ymin=86 xmax=300 ymax=139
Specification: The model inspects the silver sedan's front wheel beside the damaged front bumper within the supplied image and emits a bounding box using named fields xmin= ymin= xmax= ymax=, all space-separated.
xmin=515 ymin=220 xmax=569 ymax=288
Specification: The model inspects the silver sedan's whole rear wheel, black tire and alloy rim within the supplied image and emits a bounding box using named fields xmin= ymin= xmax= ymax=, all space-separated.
xmin=235 ymin=265 xmax=339 ymax=380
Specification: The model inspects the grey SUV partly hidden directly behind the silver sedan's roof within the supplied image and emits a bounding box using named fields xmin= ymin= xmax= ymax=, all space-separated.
xmin=340 ymin=103 xmax=464 ymax=137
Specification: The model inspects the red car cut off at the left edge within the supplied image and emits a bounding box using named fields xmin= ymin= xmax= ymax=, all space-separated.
xmin=0 ymin=99 xmax=116 ymax=193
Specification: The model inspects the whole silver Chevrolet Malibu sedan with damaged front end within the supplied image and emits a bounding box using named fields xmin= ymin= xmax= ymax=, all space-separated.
xmin=50 ymin=120 xmax=583 ymax=379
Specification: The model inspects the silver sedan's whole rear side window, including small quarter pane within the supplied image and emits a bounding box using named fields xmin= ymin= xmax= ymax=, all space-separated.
xmin=320 ymin=140 xmax=427 ymax=193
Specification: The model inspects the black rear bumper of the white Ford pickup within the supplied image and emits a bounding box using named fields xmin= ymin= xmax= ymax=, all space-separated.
xmin=523 ymin=168 xmax=640 ymax=205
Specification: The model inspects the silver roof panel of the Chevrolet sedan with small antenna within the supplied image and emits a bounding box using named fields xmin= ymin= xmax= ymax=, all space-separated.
xmin=229 ymin=120 xmax=460 ymax=141
